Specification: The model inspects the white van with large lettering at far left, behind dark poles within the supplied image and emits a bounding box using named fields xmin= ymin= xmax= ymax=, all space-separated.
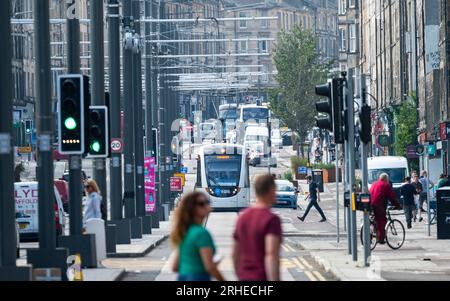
xmin=14 ymin=182 xmax=65 ymax=240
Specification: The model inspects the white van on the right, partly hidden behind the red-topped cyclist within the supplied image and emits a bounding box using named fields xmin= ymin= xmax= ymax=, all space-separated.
xmin=367 ymin=157 xmax=409 ymax=195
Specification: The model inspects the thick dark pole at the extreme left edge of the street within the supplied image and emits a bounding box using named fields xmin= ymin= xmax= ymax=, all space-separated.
xmin=0 ymin=0 xmax=32 ymax=281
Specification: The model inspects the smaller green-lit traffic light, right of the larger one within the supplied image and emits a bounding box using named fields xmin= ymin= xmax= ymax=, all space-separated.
xmin=87 ymin=106 xmax=109 ymax=158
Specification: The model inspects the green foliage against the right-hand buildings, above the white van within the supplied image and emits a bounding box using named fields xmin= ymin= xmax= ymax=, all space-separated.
xmin=394 ymin=97 xmax=417 ymax=156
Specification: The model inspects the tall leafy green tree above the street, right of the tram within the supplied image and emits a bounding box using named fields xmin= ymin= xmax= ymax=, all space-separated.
xmin=269 ymin=25 xmax=333 ymax=150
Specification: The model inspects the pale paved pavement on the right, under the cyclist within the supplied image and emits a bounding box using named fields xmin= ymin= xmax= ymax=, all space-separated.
xmin=294 ymin=182 xmax=450 ymax=281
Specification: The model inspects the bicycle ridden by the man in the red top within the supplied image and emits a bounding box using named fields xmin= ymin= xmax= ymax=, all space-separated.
xmin=360 ymin=208 xmax=406 ymax=251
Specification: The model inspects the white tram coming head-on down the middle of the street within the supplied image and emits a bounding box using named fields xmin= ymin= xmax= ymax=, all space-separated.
xmin=196 ymin=143 xmax=250 ymax=211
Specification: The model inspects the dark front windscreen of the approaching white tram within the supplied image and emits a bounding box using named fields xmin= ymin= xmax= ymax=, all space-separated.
xmin=205 ymin=155 xmax=242 ymax=196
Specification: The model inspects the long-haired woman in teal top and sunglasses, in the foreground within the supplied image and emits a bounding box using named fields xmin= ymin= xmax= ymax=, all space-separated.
xmin=170 ymin=192 xmax=225 ymax=281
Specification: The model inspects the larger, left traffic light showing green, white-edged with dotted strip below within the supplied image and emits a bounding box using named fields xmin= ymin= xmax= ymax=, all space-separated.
xmin=57 ymin=74 xmax=89 ymax=155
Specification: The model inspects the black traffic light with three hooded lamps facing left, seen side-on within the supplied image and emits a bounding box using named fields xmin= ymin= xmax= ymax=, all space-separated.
xmin=316 ymin=78 xmax=345 ymax=143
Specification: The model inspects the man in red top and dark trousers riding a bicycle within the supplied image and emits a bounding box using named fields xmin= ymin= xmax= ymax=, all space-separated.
xmin=370 ymin=173 xmax=401 ymax=244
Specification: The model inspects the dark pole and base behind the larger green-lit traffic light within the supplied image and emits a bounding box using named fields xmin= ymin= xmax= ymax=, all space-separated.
xmin=57 ymin=0 xmax=97 ymax=268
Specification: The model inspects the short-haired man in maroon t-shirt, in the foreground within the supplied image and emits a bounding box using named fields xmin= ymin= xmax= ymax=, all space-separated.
xmin=233 ymin=175 xmax=282 ymax=281
